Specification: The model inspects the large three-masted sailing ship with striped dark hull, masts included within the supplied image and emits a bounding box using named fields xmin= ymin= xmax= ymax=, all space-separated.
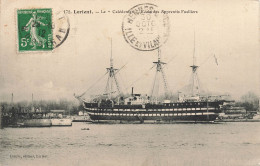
xmin=75 ymin=40 xmax=224 ymax=123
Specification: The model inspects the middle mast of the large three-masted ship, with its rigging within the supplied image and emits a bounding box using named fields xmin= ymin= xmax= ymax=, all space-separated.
xmin=151 ymin=48 xmax=168 ymax=100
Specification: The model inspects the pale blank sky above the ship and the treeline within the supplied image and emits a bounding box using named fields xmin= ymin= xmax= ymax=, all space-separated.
xmin=0 ymin=0 xmax=260 ymax=101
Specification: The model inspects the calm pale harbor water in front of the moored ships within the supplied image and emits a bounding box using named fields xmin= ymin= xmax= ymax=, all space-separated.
xmin=0 ymin=122 xmax=260 ymax=166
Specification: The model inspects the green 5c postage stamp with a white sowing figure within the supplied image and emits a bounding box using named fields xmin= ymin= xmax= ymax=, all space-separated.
xmin=17 ymin=9 xmax=53 ymax=52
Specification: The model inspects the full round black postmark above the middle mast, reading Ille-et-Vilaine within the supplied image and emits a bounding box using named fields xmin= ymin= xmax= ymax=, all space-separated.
xmin=122 ymin=3 xmax=170 ymax=51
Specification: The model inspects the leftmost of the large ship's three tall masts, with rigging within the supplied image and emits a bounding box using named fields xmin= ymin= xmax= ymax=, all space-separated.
xmin=105 ymin=39 xmax=121 ymax=99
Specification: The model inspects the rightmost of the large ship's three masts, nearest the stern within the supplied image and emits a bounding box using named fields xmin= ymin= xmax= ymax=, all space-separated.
xmin=190 ymin=32 xmax=200 ymax=96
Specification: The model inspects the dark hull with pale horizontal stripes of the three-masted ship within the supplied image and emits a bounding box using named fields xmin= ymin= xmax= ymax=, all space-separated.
xmin=84 ymin=102 xmax=221 ymax=123
